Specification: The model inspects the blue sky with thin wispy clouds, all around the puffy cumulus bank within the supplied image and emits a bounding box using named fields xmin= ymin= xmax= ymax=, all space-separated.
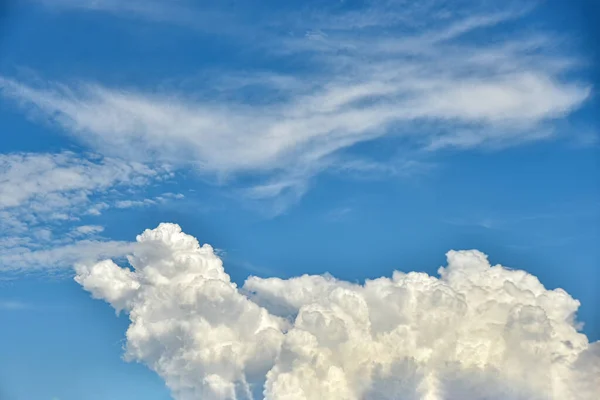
xmin=0 ymin=0 xmax=600 ymax=400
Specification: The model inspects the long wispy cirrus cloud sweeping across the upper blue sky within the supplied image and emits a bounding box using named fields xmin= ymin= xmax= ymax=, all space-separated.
xmin=0 ymin=6 xmax=590 ymax=211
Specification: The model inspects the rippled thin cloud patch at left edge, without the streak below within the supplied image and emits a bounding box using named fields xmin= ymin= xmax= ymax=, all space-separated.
xmin=0 ymin=152 xmax=163 ymax=239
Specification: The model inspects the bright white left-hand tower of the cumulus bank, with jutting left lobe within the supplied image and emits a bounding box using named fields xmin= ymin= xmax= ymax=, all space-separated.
xmin=75 ymin=224 xmax=287 ymax=400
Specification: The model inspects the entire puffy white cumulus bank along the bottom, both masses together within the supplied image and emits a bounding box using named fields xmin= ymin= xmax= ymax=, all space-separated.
xmin=75 ymin=224 xmax=600 ymax=400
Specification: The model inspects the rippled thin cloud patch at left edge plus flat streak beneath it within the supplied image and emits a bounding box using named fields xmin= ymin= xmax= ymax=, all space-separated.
xmin=0 ymin=152 xmax=174 ymax=271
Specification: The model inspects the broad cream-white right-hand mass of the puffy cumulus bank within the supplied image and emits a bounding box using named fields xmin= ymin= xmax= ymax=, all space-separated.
xmin=246 ymin=251 xmax=600 ymax=399
